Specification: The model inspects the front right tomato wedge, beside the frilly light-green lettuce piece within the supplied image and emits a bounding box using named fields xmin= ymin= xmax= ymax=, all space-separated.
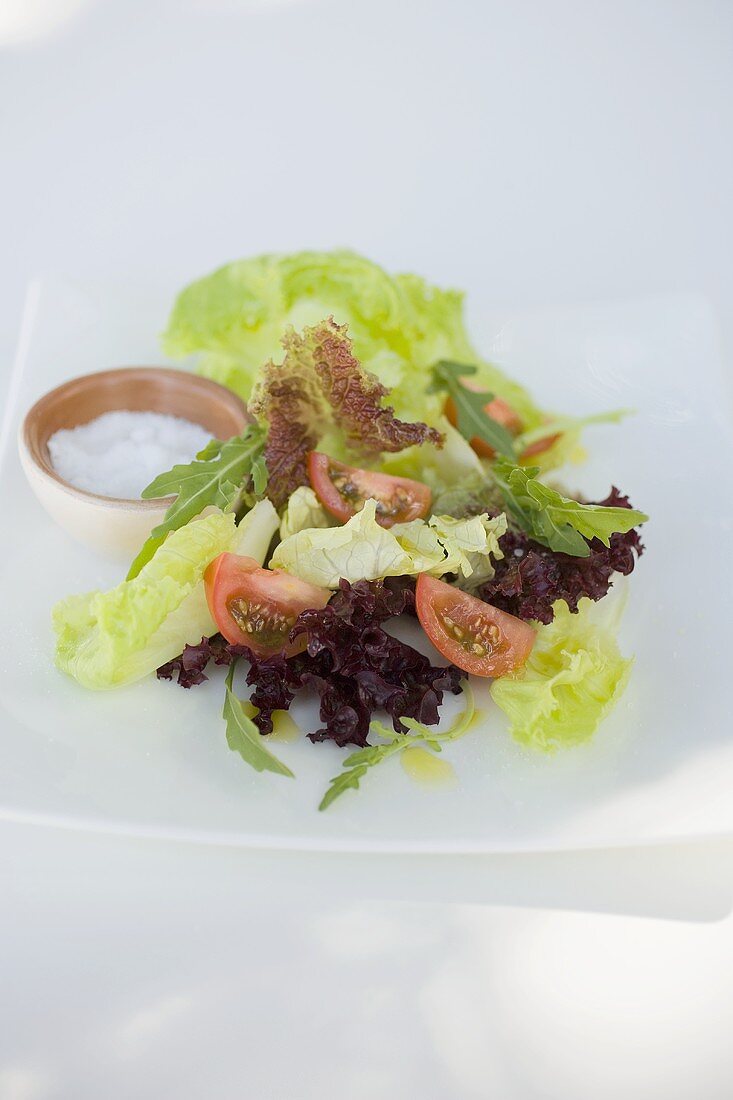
xmin=416 ymin=573 xmax=536 ymax=677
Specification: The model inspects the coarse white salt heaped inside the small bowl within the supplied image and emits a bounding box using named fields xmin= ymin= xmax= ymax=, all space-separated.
xmin=48 ymin=410 xmax=211 ymax=501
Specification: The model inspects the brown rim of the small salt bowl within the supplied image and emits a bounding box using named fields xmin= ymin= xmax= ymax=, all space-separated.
xmin=19 ymin=365 xmax=249 ymax=512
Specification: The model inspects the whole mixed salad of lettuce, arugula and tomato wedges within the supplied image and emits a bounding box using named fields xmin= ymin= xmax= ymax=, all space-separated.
xmin=54 ymin=252 xmax=647 ymax=809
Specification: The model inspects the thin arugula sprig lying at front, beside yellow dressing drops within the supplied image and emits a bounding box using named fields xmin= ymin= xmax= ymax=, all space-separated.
xmin=318 ymin=680 xmax=477 ymax=810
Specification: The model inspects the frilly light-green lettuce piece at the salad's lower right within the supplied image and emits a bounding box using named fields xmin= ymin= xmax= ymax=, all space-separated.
xmin=491 ymin=600 xmax=633 ymax=751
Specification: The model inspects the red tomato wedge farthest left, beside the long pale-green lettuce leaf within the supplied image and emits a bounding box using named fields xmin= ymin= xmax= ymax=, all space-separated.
xmin=204 ymin=553 xmax=332 ymax=657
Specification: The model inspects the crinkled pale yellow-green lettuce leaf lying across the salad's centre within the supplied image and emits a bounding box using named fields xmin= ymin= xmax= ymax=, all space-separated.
xmin=270 ymin=501 xmax=506 ymax=589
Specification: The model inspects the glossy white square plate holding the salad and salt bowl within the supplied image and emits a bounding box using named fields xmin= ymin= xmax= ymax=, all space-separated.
xmin=0 ymin=281 xmax=733 ymax=853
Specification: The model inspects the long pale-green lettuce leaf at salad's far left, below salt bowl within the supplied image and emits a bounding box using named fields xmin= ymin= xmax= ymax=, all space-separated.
xmin=53 ymin=501 xmax=278 ymax=689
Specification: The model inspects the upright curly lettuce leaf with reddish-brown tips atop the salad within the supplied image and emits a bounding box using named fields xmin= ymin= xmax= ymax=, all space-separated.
xmin=250 ymin=317 xmax=444 ymax=507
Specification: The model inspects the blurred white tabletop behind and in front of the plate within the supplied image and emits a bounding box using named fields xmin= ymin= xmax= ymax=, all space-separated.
xmin=0 ymin=0 xmax=733 ymax=1100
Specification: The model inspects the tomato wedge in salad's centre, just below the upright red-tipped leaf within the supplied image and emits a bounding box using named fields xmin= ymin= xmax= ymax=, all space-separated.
xmin=308 ymin=451 xmax=431 ymax=527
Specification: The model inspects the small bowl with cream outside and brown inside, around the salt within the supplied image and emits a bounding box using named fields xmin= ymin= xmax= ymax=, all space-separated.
xmin=18 ymin=366 xmax=249 ymax=558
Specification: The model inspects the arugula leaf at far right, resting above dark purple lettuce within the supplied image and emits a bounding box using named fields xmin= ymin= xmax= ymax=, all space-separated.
xmin=492 ymin=459 xmax=649 ymax=558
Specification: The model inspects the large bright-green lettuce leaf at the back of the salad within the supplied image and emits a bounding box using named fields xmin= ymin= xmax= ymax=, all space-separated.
xmin=163 ymin=250 xmax=543 ymax=428
